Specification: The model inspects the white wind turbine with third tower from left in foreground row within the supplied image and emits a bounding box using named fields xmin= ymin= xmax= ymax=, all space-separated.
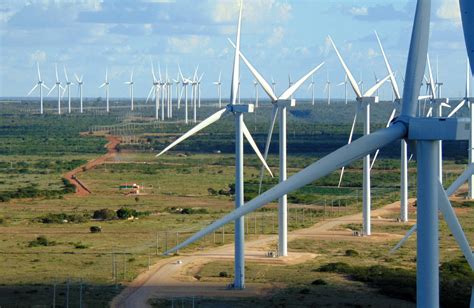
xmin=329 ymin=36 xmax=390 ymax=235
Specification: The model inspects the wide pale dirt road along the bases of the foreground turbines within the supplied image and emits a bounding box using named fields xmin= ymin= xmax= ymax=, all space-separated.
xmin=111 ymin=200 xmax=414 ymax=308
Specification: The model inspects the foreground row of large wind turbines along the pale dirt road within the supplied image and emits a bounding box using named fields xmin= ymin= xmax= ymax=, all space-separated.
xmin=153 ymin=0 xmax=474 ymax=307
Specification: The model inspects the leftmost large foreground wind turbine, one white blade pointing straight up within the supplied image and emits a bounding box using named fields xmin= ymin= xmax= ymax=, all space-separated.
xmin=157 ymin=2 xmax=271 ymax=289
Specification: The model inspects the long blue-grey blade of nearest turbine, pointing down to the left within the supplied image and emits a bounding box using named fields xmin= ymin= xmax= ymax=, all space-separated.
xmin=164 ymin=123 xmax=407 ymax=255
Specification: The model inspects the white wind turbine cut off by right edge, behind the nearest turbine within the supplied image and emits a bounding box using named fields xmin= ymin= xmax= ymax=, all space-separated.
xmin=448 ymin=58 xmax=474 ymax=199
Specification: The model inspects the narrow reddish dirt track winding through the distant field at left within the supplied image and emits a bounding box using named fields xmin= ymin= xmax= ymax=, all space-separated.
xmin=63 ymin=136 xmax=120 ymax=196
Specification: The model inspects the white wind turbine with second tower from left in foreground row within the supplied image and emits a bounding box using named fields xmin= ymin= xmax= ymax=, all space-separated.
xmin=231 ymin=37 xmax=324 ymax=257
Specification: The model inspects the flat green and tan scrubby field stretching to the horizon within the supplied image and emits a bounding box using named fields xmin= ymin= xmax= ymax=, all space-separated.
xmin=0 ymin=102 xmax=474 ymax=307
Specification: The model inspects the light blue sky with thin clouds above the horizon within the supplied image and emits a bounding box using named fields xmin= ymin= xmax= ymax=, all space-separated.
xmin=0 ymin=0 xmax=466 ymax=97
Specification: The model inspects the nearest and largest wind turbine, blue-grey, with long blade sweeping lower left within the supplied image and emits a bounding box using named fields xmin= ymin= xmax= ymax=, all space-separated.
xmin=165 ymin=0 xmax=474 ymax=308
